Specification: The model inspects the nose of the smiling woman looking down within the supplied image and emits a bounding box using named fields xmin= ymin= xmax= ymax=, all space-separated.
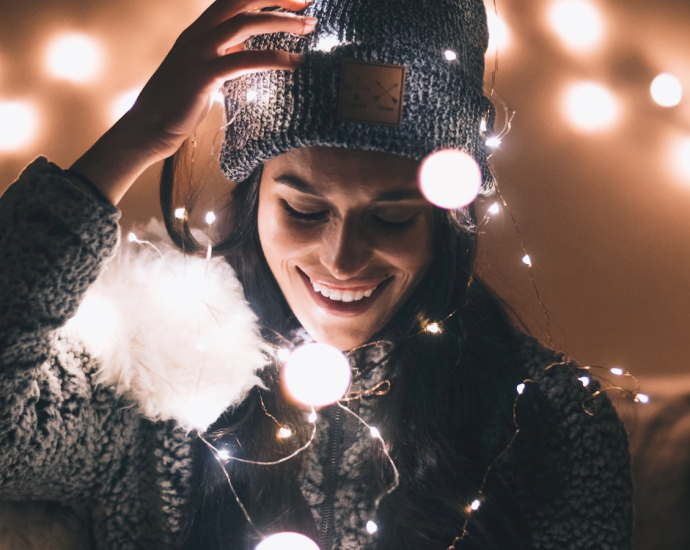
xmin=320 ymin=213 xmax=372 ymax=281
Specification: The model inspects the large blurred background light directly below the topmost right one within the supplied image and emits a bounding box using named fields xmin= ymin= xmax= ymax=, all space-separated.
xmin=563 ymin=82 xmax=621 ymax=133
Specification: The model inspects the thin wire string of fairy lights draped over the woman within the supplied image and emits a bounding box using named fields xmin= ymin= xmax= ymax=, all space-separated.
xmin=117 ymin=3 xmax=649 ymax=550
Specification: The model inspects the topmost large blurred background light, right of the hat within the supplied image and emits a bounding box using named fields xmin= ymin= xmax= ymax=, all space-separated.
xmin=547 ymin=0 xmax=605 ymax=53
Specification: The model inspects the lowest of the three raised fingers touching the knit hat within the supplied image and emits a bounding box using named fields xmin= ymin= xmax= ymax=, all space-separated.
xmin=211 ymin=50 xmax=304 ymax=81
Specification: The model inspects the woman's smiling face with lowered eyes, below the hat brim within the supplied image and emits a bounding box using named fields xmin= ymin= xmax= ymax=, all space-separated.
xmin=258 ymin=147 xmax=432 ymax=350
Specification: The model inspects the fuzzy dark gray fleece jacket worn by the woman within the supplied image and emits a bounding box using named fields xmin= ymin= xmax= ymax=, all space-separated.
xmin=0 ymin=159 xmax=632 ymax=550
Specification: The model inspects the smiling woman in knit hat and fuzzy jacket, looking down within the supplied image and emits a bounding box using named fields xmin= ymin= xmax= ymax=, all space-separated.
xmin=0 ymin=0 xmax=632 ymax=549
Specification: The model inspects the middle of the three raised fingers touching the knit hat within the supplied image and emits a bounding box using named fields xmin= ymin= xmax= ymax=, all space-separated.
xmin=202 ymin=12 xmax=317 ymax=56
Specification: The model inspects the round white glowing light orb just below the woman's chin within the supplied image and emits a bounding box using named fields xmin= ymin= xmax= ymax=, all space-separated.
xmin=283 ymin=344 xmax=351 ymax=407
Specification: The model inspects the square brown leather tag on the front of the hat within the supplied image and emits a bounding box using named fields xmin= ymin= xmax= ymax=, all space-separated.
xmin=338 ymin=59 xmax=406 ymax=126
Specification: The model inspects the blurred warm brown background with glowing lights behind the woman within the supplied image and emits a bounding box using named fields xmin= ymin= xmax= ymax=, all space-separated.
xmin=0 ymin=0 xmax=690 ymax=384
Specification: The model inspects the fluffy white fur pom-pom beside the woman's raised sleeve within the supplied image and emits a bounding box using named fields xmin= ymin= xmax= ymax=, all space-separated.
xmin=65 ymin=222 xmax=267 ymax=432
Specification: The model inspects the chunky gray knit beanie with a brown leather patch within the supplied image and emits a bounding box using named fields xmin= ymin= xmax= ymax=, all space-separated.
xmin=220 ymin=0 xmax=494 ymax=194
